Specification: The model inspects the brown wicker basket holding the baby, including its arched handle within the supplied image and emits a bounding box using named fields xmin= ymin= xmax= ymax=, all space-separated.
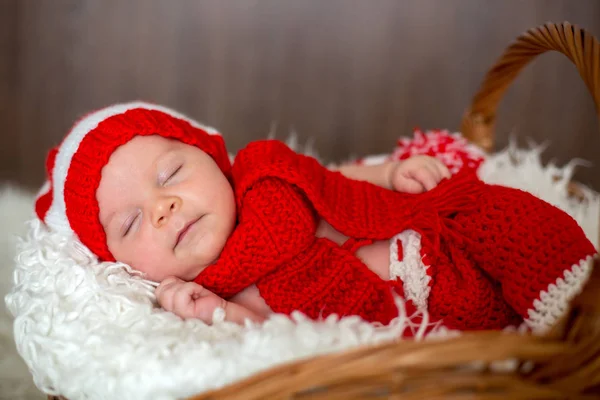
xmin=50 ymin=23 xmax=600 ymax=400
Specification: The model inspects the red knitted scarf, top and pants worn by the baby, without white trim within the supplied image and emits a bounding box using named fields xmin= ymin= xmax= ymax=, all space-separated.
xmin=195 ymin=141 xmax=594 ymax=329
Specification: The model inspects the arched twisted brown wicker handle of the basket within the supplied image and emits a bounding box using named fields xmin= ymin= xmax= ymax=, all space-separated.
xmin=461 ymin=22 xmax=600 ymax=152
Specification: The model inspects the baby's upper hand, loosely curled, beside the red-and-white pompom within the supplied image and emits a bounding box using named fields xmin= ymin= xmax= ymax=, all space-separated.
xmin=390 ymin=155 xmax=451 ymax=194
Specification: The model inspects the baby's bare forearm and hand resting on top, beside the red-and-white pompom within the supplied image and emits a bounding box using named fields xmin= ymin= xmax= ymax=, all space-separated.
xmin=337 ymin=155 xmax=450 ymax=193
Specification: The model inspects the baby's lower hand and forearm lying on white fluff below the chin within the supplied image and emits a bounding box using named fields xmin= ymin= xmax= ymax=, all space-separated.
xmin=155 ymin=277 xmax=265 ymax=324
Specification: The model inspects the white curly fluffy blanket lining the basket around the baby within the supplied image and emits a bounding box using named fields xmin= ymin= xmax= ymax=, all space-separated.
xmin=0 ymin=140 xmax=599 ymax=400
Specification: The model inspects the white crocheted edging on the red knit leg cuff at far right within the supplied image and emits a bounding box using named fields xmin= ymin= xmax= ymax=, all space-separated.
xmin=525 ymin=256 xmax=593 ymax=334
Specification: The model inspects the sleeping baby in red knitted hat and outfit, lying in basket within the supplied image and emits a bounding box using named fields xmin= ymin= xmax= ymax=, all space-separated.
xmin=36 ymin=103 xmax=595 ymax=330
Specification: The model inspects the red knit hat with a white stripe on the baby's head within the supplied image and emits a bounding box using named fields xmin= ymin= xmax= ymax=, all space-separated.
xmin=35 ymin=102 xmax=231 ymax=261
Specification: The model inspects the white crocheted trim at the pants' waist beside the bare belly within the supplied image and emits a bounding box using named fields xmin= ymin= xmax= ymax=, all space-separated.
xmin=390 ymin=229 xmax=431 ymax=310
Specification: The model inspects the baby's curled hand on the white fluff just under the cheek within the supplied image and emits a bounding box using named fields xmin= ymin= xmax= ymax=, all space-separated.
xmin=155 ymin=277 xmax=227 ymax=324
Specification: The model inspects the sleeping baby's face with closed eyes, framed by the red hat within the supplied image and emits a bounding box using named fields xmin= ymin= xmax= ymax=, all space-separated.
xmin=96 ymin=136 xmax=236 ymax=281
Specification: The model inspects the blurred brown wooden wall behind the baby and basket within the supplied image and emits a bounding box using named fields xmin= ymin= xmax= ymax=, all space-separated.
xmin=0 ymin=0 xmax=600 ymax=189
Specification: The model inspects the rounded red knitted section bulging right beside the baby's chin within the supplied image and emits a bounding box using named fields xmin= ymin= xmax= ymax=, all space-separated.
xmin=194 ymin=178 xmax=317 ymax=298
